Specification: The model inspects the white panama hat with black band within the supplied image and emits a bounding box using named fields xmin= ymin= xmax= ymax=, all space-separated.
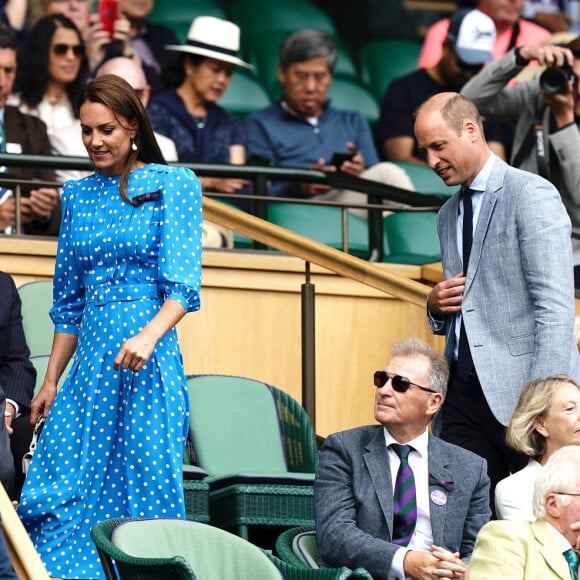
xmin=165 ymin=16 xmax=254 ymax=68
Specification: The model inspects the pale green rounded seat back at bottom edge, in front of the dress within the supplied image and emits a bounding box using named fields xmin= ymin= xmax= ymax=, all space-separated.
xmin=111 ymin=519 xmax=283 ymax=580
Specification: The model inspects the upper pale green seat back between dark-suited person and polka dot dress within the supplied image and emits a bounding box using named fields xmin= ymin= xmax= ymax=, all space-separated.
xmin=18 ymin=280 xmax=54 ymax=358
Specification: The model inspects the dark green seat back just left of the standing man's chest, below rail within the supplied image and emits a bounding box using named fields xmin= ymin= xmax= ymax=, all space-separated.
xmin=383 ymin=211 xmax=441 ymax=265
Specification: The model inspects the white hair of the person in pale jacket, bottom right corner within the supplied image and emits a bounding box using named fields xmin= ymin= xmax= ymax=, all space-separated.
xmin=533 ymin=445 xmax=580 ymax=518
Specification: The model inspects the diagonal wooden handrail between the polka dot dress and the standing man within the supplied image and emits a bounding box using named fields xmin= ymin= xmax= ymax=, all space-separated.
xmin=203 ymin=196 xmax=431 ymax=306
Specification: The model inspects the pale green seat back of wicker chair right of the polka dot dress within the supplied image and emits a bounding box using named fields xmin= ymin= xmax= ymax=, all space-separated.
xmin=187 ymin=375 xmax=288 ymax=476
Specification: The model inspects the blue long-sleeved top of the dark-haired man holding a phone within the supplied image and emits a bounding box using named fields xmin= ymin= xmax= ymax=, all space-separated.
xmin=246 ymin=102 xmax=379 ymax=197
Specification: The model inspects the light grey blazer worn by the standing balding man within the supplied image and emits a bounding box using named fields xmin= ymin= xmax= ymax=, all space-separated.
xmin=427 ymin=158 xmax=580 ymax=425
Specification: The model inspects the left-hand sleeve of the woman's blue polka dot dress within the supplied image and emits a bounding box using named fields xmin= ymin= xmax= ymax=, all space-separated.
xmin=50 ymin=181 xmax=85 ymax=335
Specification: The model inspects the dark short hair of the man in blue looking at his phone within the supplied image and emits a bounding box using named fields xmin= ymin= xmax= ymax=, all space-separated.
xmin=278 ymin=28 xmax=338 ymax=71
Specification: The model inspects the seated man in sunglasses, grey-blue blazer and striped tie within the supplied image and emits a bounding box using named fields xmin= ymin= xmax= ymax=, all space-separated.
xmin=314 ymin=338 xmax=491 ymax=580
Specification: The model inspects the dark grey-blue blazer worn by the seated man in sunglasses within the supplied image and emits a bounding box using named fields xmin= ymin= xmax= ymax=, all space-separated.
xmin=314 ymin=425 xmax=491 ymax=580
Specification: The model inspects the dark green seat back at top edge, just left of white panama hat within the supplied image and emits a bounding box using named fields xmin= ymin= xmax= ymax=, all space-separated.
xmin=149 ymin=0 xmax=228 ymax=43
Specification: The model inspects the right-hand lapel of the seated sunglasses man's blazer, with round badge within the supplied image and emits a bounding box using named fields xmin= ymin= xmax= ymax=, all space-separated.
xmin=427 ymin=435 xmax=454 ymax=547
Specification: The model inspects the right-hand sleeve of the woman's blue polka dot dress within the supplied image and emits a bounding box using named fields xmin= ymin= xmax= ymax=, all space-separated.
xmin=159 ymin=167 xmax=202 ymax=312
